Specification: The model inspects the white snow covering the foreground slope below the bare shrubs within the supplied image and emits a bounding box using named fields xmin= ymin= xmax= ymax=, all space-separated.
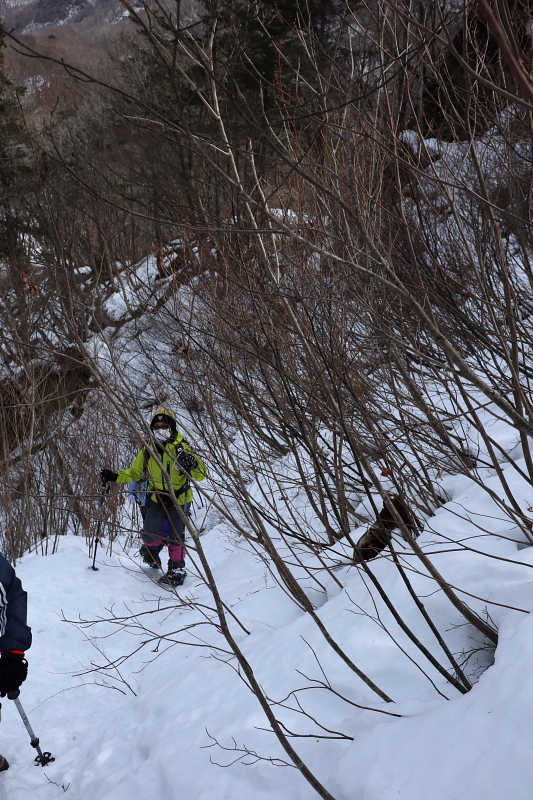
xmin=0 ymin=460 xmax=533 ymax=800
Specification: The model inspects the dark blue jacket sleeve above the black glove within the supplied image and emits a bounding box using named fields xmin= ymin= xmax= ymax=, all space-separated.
xmin=0 ymin=553 xmax=31 ymax=652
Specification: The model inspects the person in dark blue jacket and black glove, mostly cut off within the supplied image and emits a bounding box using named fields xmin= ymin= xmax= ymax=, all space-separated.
xmin=0 ymin=553 xmax=31 ymax=772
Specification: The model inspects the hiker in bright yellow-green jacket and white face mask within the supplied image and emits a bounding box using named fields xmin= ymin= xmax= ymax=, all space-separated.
xmin=100 ymin=408 xmax=207 ymax=586
